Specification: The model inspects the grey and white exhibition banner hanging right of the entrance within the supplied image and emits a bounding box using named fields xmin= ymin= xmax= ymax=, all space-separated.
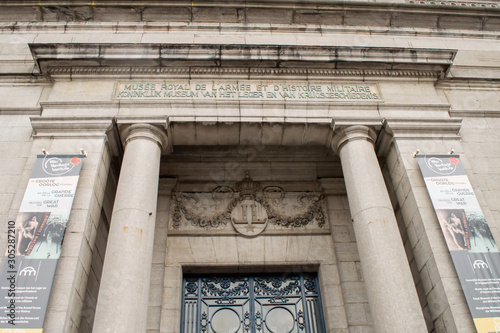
xmin=417 ymin=155 xmax=500 ymax=333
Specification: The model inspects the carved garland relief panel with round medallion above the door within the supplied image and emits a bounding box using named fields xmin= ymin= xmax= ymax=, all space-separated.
xmin=170 ymin=173 xmax=326 ymax=236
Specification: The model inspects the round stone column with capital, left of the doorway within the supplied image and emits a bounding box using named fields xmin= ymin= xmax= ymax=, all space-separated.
xmin=93 ymin=124 xmax=167 ymax=333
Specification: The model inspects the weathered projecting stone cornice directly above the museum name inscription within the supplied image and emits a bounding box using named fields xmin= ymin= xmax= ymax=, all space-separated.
xmin=30 ymin=43 xmax=456 ymax=78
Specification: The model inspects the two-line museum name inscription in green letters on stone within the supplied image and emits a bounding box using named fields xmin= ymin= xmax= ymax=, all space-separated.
xmin=115 ymin=80 xmax=382 ymax=102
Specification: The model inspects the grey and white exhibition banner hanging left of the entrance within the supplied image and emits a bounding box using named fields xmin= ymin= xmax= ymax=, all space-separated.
xmin=0 ymin=155 xmax=84 ymax=333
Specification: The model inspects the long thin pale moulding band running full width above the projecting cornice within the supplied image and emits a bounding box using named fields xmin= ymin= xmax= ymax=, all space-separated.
xmin=0 ymin=21 xmax=498 ymax=39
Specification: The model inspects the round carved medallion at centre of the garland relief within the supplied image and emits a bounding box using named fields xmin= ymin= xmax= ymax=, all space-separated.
xmin=231 ymin=199 xmax=268 ymax=236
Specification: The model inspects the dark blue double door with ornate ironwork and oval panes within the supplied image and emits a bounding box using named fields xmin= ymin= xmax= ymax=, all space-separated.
xmin=181 ymin=273 xmax=326 ymax=333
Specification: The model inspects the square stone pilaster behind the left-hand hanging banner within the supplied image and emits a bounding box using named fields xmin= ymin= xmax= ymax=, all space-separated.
xmin=29 ymin=116 xmax=119 ymax=333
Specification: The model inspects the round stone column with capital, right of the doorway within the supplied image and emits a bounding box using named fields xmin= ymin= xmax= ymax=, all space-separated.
xmin=332 ymin=126 xmax=427 ymax=333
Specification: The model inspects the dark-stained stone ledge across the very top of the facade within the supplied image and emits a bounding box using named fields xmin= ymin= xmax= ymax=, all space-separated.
xmin=0 ymin=0 xmax=498 ymax=30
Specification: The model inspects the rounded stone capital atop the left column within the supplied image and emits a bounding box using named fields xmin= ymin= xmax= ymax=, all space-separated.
xmin=118 ymin=122 xmax=168 ymax=151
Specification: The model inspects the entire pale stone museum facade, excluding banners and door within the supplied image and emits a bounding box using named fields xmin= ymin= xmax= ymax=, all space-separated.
xmin=0 ymin=0 xmax=500 ymax=333
